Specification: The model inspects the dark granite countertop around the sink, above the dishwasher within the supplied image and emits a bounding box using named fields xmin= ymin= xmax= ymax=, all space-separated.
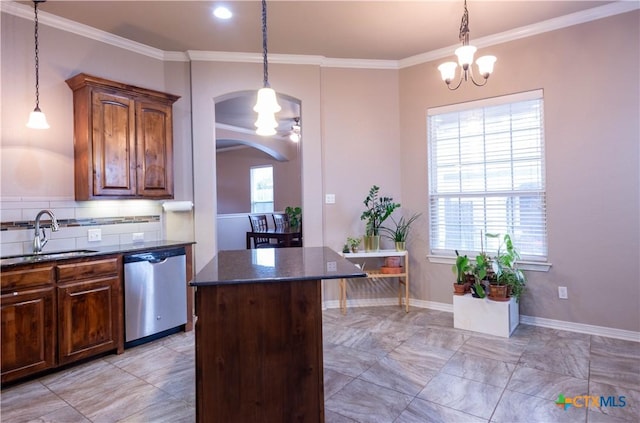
xmin=0 ymin=240 xmax=194 ymax=268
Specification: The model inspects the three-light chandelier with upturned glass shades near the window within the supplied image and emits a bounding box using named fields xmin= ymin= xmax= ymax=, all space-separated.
xmin=438 ymin=0 xmax=496 ymax=91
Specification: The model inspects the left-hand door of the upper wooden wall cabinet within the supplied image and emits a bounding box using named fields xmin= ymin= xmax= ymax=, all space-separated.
xmin=91 ymin=90 xmax=136 ymax=196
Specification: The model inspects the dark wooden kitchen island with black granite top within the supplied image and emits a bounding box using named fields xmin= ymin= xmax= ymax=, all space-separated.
xmin=191 ymin=247 xmax=366 ymax=423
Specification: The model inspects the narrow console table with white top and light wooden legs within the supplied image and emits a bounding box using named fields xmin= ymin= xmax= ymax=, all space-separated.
xmin=340 ymin=250 xmax=409 ymax=314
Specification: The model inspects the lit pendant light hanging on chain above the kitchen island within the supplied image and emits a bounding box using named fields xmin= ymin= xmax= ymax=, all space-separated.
xmin=253 ymin=0 xmax=282 ymax=136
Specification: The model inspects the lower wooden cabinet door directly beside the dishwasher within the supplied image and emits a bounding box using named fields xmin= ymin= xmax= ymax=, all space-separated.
xmin=58 ymin=276 xmax=122 ymax=364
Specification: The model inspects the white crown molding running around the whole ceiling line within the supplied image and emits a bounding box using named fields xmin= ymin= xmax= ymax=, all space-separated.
xmin=0 ymin=0 xmax=640 ymax=69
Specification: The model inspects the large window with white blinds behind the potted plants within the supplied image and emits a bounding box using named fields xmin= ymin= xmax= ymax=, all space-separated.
xmin=427 ymin=90 xmax=547 ymax=261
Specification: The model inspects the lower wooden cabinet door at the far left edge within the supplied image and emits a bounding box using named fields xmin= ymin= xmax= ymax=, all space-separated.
xmin=1 ymin=287 xmax=56 ymax=383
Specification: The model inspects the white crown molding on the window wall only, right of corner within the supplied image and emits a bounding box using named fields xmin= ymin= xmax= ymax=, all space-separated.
xmin=399 ymin=1 xmax=640 ymax=69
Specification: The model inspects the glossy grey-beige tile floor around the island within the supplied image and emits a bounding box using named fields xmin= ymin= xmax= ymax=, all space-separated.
xmin=0 ymin=307 xmax=640 ymax=423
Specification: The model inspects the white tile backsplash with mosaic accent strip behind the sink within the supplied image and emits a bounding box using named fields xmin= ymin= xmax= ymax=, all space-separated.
xmin=0 ymin=198 xmax=164 ymax=256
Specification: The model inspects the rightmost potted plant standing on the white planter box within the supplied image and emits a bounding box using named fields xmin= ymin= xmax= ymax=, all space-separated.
xmin=489 ymin=234 xmax=527 ymax=302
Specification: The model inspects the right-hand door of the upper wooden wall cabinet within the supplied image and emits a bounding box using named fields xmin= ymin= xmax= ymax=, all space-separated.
xmin=136 ymin=100 xmax=173 ymax=198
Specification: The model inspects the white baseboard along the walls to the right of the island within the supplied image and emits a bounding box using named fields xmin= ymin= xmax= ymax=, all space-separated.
xmin=323 ymin=298 xmax=640 ymax=342
